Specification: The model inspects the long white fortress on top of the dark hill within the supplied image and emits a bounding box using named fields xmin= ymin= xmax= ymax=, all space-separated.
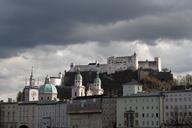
xmin=69 ymin=53 xmax=161 ymax=74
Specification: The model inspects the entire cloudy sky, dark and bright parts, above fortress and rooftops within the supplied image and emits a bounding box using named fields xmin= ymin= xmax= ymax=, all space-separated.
xmin=0 ymin=0 xmax=192 ymax=100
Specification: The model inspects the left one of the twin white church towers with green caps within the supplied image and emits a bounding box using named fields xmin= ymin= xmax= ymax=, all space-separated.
xmin=72 ymin=69 xmax=85 ymax=98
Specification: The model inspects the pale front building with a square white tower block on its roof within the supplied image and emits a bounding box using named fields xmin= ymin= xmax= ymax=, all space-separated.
xmin=116 ymin=83 xmax=164 ymax=128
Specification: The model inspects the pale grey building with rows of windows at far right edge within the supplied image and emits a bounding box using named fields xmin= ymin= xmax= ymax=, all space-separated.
xmin=164 ymin=90 xmax=192 ymax=126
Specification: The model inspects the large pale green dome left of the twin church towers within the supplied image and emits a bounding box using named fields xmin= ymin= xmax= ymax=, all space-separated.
xmin=39 ymin=84 xmax=57 ymax=94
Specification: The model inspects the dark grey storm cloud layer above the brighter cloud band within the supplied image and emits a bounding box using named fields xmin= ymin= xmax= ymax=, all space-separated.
xmin=0 ymin=0 xmax=192 ymax=57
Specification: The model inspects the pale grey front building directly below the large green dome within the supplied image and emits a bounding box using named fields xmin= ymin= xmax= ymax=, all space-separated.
xmin=38 ymin=101 xmax=68 ymax=128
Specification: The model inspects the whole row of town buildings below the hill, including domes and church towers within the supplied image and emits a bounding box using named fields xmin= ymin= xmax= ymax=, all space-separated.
xmin=0 ymin=70 xmax=192 ymax=128
